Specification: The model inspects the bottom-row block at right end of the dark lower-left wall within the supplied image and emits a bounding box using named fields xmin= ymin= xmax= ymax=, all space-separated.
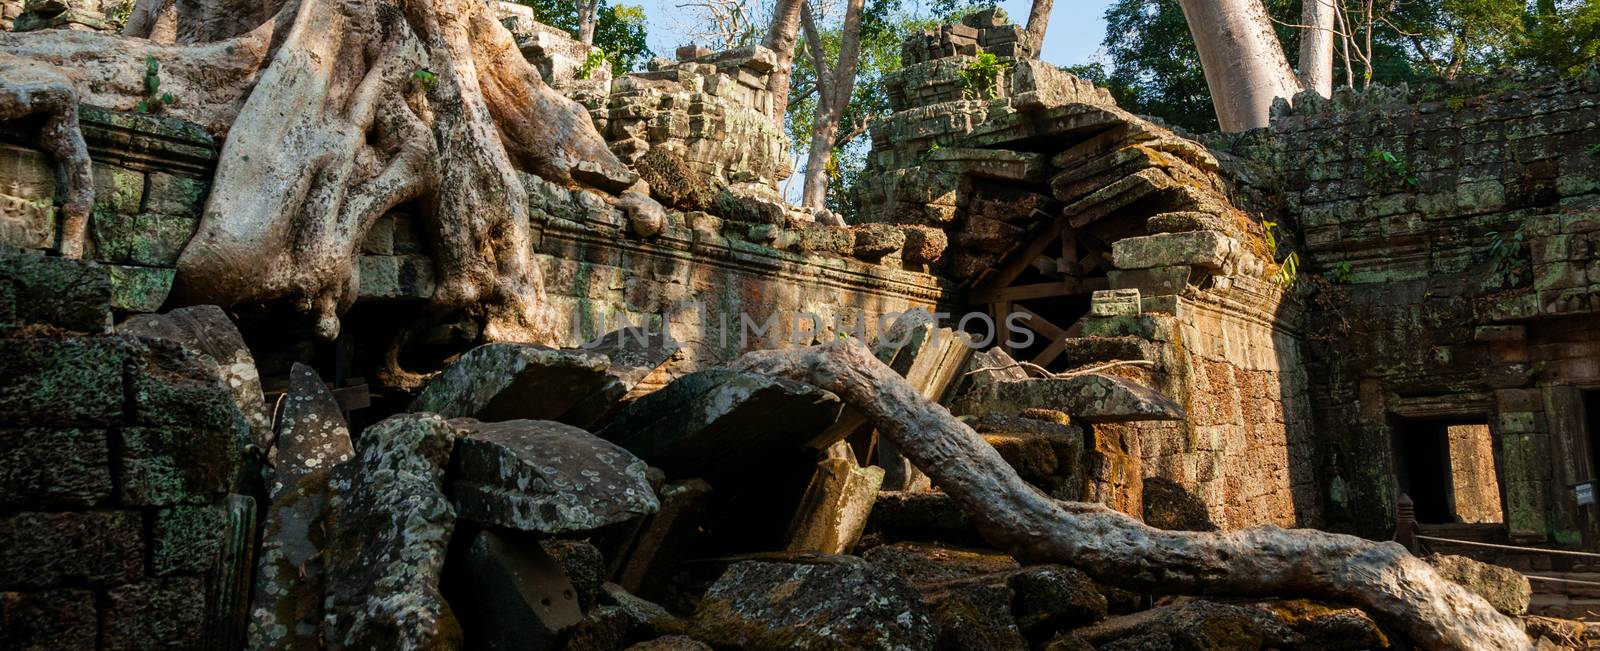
xmin=101 ymin=576 xmax=205 ymax=649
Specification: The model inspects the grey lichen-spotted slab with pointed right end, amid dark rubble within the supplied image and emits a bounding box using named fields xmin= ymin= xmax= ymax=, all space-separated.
xmin=450 ymin=419 xmax=659 ymax=534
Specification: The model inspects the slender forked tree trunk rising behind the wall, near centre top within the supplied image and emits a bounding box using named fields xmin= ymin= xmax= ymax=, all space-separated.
xmin=800 ymin=0 xmax=864 ymax=208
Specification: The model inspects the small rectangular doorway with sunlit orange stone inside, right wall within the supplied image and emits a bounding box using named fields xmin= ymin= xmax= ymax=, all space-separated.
xmin=1394 ymin=421 xmax=1506 ymax=526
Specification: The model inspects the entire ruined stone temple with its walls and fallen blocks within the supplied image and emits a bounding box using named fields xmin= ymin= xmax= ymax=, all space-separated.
xmin=0 ymin=0 xmax=1600 ymax=649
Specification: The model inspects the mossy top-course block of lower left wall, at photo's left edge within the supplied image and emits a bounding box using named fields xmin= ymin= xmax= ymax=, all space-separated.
xmin=0 ymin=253 xmax=110 ymax=333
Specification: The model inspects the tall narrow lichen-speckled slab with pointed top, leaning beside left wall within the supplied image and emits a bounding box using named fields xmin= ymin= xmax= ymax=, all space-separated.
xmin=250 ymin=363 xmax=355 ymax=649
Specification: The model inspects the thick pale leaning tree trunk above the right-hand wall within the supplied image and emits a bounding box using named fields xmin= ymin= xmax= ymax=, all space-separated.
xmin=1179 ymin=0 xmax=1299 ymax=131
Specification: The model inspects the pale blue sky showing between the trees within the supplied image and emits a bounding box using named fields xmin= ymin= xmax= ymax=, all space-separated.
xmin=636 ymin=0 xmax=1112 ymax=66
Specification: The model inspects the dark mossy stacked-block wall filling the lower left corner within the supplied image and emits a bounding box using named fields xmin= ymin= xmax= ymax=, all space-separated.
xmin=0 ymin=253 xmax=254 ymax=649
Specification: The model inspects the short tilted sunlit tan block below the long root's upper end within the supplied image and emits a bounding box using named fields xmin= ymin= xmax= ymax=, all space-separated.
xmin=789 ymin=457 xmax=883 ymax=553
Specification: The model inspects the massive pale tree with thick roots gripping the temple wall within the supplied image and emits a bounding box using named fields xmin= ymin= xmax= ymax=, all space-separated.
xmin=0 ymin=0 xmax=664 ymax=367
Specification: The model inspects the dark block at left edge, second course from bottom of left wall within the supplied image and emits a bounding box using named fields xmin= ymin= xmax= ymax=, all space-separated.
xmin=0 ymin=510 xmax=144 ymax=590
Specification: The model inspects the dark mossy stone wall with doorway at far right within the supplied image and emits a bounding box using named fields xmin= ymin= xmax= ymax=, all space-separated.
xmin=1214 ymin=70 xmax=1600 ymax=544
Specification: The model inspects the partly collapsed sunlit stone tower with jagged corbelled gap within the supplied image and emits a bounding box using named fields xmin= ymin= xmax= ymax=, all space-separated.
xmin=858 ymin=11 xmax=1322 ymax=528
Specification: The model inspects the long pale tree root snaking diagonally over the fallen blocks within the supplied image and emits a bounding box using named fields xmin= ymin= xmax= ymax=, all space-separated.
xmin=736 ymin=339 xmax=1531 ymax=649
